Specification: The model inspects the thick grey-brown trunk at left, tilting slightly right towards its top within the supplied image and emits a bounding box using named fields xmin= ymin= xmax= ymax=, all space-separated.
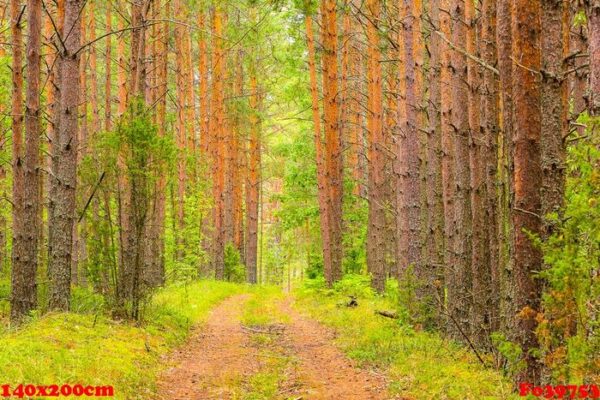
xmin=48 ymin=0 xmax=83 ymax=310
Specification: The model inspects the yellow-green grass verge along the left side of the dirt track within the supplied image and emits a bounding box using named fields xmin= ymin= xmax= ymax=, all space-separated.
xmin=0 ymin=281 xmax=247 ymax=399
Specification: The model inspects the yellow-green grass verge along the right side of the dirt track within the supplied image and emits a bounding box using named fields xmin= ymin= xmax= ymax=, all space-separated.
xmin=297 ymin=276 xmax=517 ymax=400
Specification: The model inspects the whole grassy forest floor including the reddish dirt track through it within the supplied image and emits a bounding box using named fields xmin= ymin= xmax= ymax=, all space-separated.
xmin=0 ymin=276 xmax=518 ymax=400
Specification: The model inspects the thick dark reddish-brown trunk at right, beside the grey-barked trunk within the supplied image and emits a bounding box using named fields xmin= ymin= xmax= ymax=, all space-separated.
xmin=512 ymin=0 xmax=544 ymax=384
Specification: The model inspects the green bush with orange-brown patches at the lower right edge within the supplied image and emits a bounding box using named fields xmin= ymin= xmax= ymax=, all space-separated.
xmin=538 ymin=115 xmax=600 ymax=383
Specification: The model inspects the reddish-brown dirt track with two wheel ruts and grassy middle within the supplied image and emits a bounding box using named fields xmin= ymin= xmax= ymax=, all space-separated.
xmin=158 ymin=295 xmax=390 ymax=400
